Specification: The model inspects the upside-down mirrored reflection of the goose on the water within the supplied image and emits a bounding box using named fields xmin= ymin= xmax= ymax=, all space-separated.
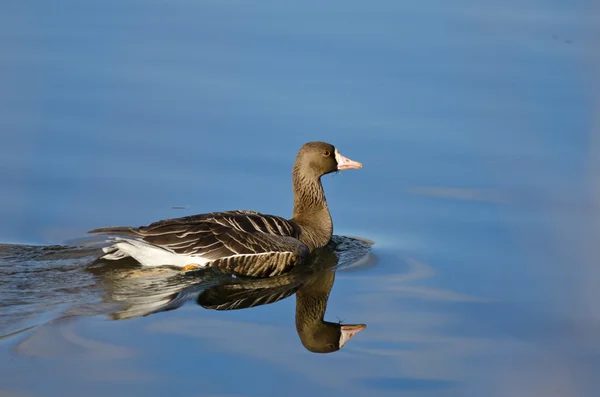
xmin=90 ymin=236 xmax=373 ymax=353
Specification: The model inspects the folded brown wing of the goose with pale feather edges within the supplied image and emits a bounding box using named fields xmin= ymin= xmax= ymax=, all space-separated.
xmin=90 ymin=210 xmax=309 ymax=276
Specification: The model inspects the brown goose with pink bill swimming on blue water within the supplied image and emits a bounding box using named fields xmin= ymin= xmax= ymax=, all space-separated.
xmin=89 ymin=141 xmax=362 ymax=277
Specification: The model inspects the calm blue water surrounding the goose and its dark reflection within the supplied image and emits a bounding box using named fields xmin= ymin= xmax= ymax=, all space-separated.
xmin=0 ymin=0 xmax=600 ymax=397
